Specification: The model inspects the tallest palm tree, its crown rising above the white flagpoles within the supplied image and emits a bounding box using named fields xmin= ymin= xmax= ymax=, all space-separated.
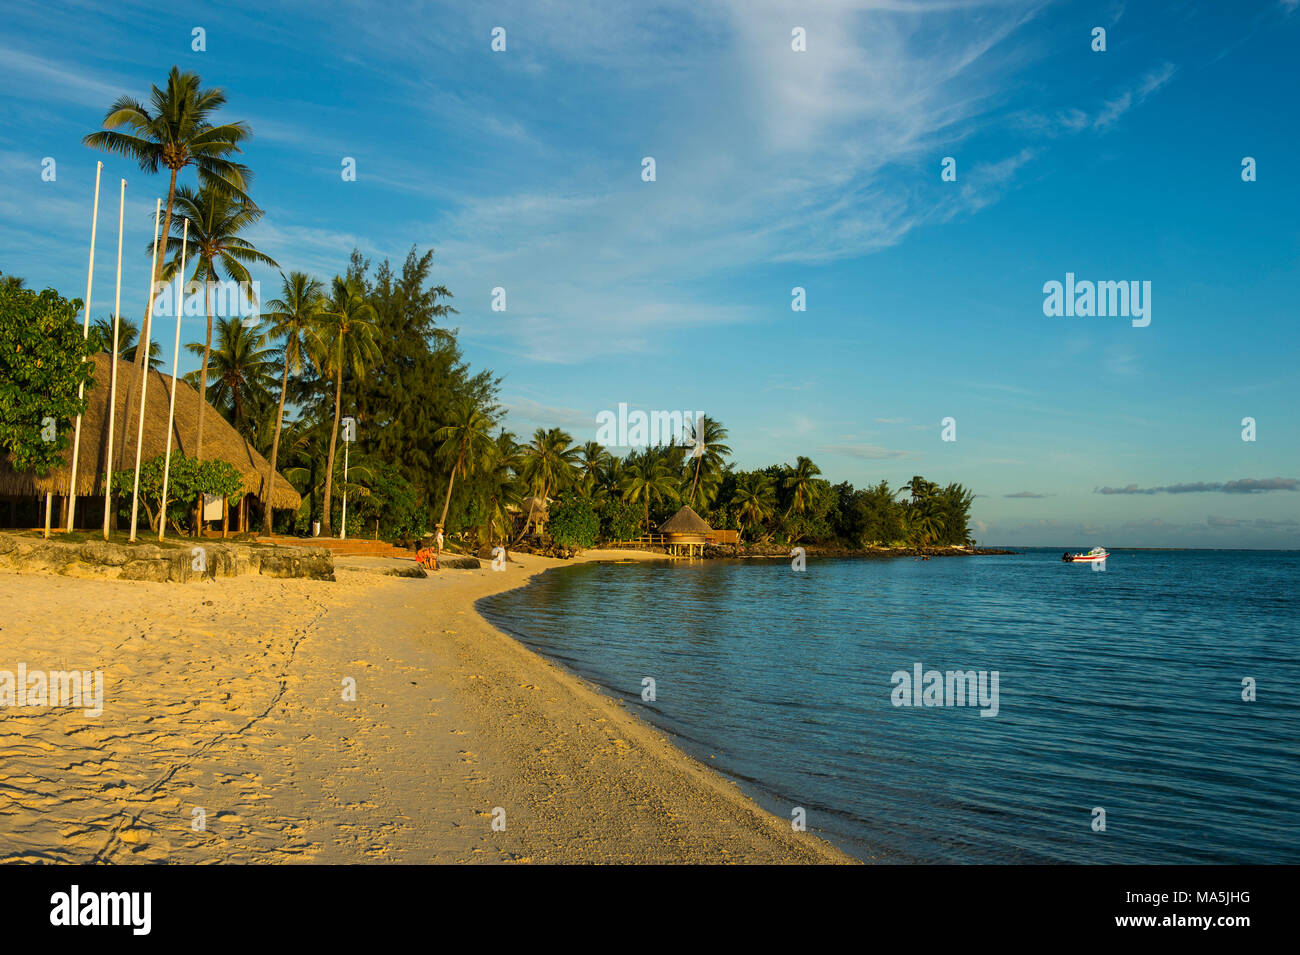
xmin=82 ymin=66 xmax=252 ymax=389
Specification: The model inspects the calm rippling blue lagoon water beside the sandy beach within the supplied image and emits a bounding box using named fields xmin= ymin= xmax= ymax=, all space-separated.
xmin=481 ymin=547 xmax=1300 ymax=863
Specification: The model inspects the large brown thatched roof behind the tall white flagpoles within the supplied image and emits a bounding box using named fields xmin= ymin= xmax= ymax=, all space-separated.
xmin=0 ymin=352 xmax=302 ymax=509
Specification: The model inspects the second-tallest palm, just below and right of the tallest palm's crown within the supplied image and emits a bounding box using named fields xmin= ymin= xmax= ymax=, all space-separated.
xmin=161 ymin=183 xmax=276 ymax=460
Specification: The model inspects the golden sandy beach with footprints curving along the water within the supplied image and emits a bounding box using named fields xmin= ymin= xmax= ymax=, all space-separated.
xmin=0 ymin=551 xmax=853 ymax=863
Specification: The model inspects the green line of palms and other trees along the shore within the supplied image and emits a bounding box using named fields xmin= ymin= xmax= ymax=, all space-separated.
xmin=7 ymin=68 xmax=972 ymax=547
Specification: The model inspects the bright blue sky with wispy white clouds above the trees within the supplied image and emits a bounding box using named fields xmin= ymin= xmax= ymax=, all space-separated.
xmin=0 ymin=0 xmax=1300 ymax=547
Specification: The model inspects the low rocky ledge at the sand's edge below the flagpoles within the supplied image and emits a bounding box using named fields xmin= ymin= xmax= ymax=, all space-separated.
xmin=0 ymin=534 xmax=334 ymax=583
